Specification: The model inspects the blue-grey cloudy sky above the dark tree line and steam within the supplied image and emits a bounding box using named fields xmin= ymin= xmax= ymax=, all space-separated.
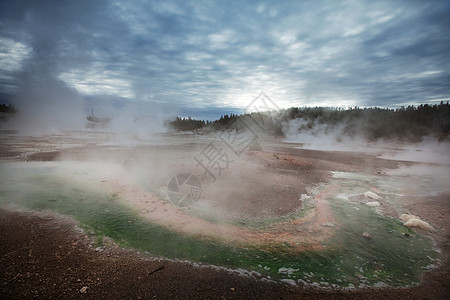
xmin=0 ymin=0 xmax=450 ymax=118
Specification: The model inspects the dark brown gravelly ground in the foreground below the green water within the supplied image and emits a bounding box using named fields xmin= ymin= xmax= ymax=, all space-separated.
xmin=0 ymin=209 xmax=450 ymax=299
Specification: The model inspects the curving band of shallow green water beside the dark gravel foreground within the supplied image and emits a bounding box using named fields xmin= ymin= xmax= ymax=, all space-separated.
xmin=0 ymin=163 xmax=437 ymax=286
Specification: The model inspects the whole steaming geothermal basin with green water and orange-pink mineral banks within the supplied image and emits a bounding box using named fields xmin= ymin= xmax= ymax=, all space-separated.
xmin=0 ymin=132 xmax=449 ymax=287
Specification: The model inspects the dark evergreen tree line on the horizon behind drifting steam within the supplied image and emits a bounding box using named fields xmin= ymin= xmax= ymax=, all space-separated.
xmin=169 ymin=102 xmax=450 ymax=142
